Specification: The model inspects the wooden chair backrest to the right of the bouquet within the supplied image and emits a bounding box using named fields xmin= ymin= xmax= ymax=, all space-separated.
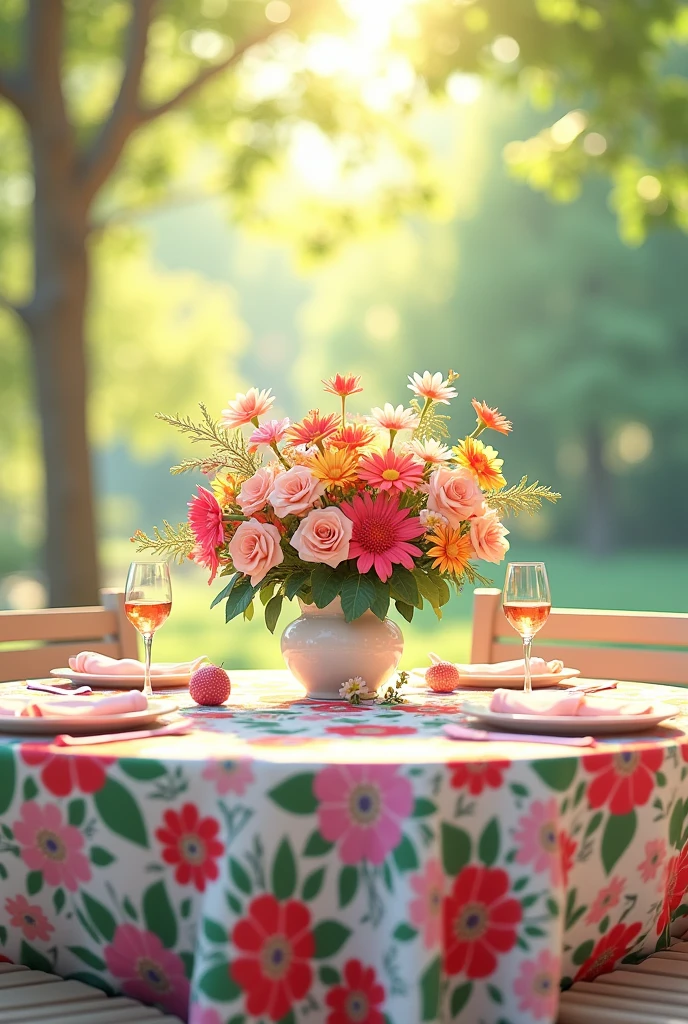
xmin=471 ymin=588 xmax=688 ymax=685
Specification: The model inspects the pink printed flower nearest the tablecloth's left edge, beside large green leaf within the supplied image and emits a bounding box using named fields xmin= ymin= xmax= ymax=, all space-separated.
xmin=12 ymin=800 xmax=91 ymax=892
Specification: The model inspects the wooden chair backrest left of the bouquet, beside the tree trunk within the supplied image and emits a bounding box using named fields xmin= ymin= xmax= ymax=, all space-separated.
xmin=0 ymin=590 xmax=138 ymax=682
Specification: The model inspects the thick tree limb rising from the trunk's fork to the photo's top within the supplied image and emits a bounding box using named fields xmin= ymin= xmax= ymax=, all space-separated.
xmin=78 ymin=0 xmax=156 ymax=199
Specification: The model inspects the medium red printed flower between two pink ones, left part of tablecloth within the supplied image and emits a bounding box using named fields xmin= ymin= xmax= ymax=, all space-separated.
xmin=156 ymin=804 xmax=224 ymax=893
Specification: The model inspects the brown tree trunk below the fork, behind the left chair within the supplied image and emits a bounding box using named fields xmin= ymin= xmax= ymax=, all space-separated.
xmin=26 ymin=142 xmax=98 ymax=605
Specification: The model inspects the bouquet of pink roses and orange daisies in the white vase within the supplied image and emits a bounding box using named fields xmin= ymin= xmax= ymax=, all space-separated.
xmin=132 ymin=371 xmax=559 ymax=692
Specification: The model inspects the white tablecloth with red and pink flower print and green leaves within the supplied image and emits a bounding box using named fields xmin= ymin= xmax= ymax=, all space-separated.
xmin=0 ymin=672 xmax=688 ymax=1024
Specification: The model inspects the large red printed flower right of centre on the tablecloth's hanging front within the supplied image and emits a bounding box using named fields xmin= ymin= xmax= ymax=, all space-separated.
xmin=443 ymin=864 xmax=523 ymax=978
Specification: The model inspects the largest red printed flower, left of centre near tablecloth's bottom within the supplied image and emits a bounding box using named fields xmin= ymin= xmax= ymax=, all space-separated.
xmin=229 ymin=894 xmax=315 ymax=1021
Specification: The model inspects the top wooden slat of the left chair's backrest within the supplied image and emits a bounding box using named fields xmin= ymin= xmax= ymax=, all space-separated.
xmin=0 ymin=605 xmax=119 ymax=643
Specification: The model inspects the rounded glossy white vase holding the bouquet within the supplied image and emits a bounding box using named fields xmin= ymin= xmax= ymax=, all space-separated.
xmin=282 ymin=598 xmax=403 ymax=700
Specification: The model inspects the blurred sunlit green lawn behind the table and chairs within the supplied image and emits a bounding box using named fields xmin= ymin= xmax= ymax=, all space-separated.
xmin=105 ymin=543 xmax=688 ymax=669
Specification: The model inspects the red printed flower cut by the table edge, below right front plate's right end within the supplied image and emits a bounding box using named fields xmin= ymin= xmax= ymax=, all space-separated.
xmin=583 ymin=750 xmax=664 ymax=814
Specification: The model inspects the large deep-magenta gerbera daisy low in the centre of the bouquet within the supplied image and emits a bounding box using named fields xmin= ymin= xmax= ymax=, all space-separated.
xmin=340 ymin=493 xmax=423 ymax=583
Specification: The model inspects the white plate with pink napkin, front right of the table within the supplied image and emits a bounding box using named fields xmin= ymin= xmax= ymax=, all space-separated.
xmin=461 ymin=700 xmax=681 ymax=736
